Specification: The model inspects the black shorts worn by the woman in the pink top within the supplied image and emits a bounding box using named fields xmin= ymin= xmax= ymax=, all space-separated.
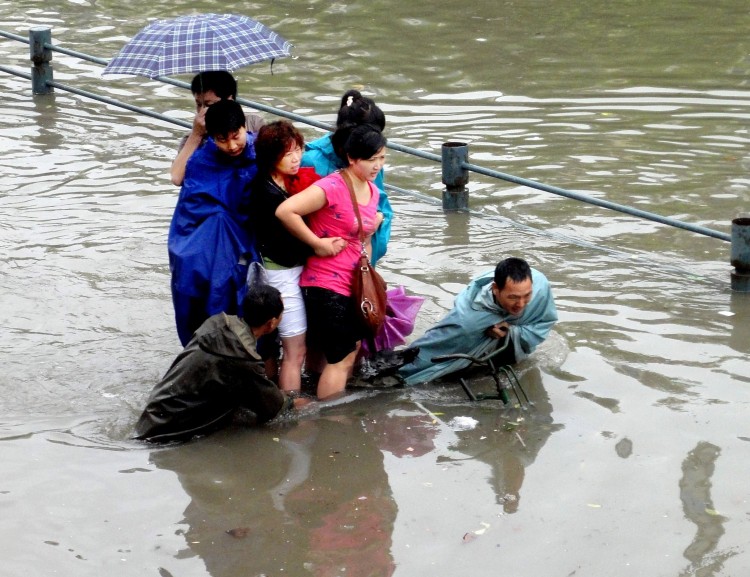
xmin=302 ymin=287 xmax=365 ymax=365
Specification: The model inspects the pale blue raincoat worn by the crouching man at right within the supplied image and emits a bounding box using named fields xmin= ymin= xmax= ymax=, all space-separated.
xmin=399 ymin=269 xmax=557 ymax=385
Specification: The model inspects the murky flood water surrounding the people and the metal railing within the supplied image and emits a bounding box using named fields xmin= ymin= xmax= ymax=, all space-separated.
xmin=0 ymin=0 xmax=750 ymax=577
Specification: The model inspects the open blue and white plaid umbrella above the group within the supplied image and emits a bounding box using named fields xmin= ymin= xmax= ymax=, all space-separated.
xmin=102 ymin=14 xmax=292 ymax=78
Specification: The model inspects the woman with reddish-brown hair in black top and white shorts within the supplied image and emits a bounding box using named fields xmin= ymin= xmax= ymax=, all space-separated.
xmin=250 ymin=120 xmax=319 ymax=391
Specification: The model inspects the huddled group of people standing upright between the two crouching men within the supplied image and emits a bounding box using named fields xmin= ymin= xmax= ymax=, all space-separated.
xmin=169 ymin=72 xmax=393 ymax=398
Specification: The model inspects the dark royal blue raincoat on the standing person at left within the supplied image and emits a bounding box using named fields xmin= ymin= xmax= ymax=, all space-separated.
xmin=168 ymin=133 xmax=259 ymax=346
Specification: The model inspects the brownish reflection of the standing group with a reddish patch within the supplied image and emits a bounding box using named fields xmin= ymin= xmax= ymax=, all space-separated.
xmin=151 ymin=414 xmax=396 ymax=577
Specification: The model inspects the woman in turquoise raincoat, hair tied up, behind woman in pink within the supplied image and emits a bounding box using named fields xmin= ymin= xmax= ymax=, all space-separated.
xmin=302 ymin=90 xmax=393 ymax=264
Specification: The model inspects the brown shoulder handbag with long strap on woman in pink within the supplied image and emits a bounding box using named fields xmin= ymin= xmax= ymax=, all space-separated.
xmin=341 ymin=171 xmax=388 ymax=337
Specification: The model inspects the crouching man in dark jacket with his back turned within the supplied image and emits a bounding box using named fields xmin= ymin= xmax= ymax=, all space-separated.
xmin=135 ymin=285 xmax=294 ymax=442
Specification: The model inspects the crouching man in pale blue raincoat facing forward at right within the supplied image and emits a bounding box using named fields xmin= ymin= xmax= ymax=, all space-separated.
xmin=399 ymin=257 xmax=557 ymax=385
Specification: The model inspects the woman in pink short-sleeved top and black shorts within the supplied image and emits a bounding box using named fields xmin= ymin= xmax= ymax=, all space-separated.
xmin=276 ymin=124 xmax=386 ymax=399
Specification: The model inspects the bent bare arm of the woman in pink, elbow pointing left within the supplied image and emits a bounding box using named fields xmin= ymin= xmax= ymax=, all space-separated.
xmin=276 ymin=184 xmax=346 ymax=256
